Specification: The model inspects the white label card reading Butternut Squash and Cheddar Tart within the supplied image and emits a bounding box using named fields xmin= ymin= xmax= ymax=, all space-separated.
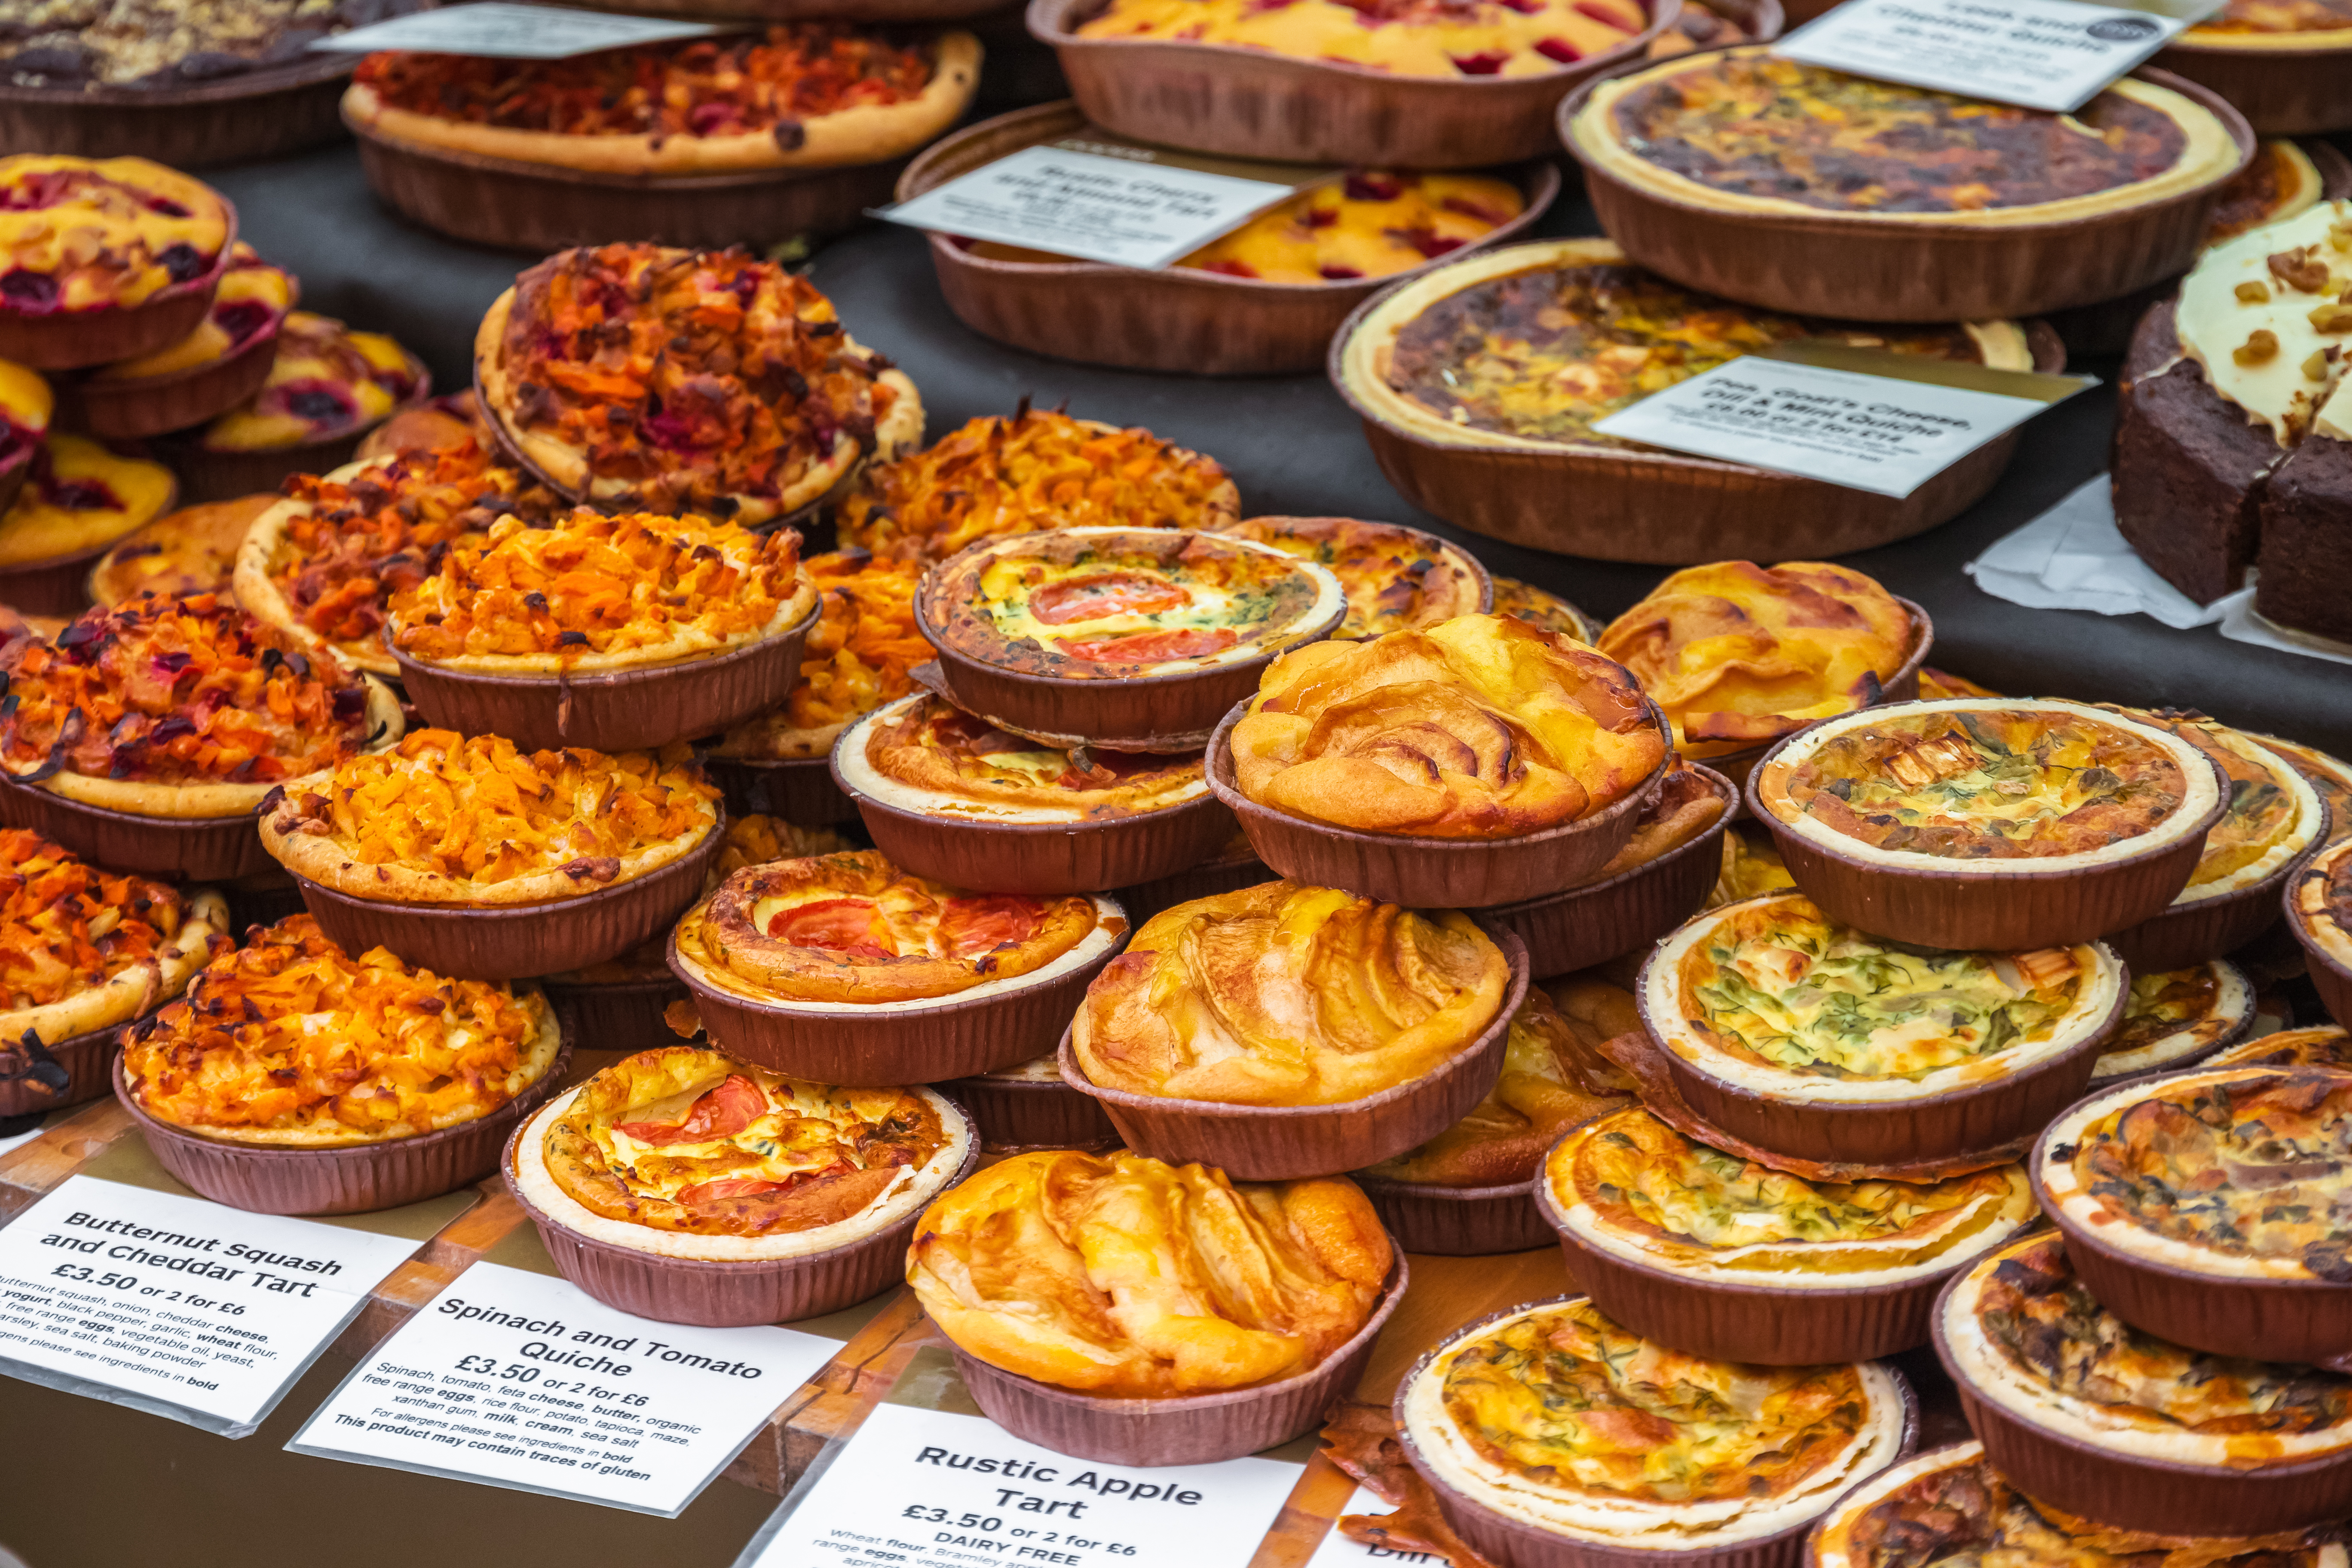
xmin=0 ymin=1176 xmax=419 ymax=1436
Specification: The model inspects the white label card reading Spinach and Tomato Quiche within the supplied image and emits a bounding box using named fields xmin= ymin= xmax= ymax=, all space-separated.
xmin=287 ymin=1262 xmax=835 ymax=1519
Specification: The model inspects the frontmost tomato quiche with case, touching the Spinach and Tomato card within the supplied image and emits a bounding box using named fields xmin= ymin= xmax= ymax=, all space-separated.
xmin=505 ymin=1046 xmax=978 ymax=1328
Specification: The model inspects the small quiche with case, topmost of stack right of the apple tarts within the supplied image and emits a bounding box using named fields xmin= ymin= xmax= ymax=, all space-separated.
xmin=1748 ymin=698 xmax=2230 ymax=957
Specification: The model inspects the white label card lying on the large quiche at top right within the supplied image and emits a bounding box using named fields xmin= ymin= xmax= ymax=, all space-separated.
xmin=1773 ymin=0 xmax=2223 ymax=113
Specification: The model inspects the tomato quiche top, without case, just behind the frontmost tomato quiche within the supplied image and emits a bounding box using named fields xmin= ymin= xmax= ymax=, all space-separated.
xmin=675 ymin=848 xmax=1124 ymax=1004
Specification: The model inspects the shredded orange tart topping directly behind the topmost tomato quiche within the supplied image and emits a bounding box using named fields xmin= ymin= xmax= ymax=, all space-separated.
xmin=835 ymin=407 xmax=1242 ymax=562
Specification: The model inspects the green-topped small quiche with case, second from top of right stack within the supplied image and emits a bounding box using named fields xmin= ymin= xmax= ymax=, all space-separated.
xmin=1639 ymin=893 xmax=2124 ymax=1166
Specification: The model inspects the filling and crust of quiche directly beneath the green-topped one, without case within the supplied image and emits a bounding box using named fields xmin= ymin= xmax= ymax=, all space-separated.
xmin=1543 ymin=1107 xmax=2034 ymax=1291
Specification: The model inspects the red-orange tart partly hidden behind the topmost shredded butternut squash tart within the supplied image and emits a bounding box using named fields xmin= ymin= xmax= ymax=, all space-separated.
xmin=235 ymin=440 xmax=557 ymax=675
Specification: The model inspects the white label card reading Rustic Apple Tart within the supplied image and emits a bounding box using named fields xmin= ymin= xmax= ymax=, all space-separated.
xmin=738 ymin=1403 xmax=1298 ymax=1568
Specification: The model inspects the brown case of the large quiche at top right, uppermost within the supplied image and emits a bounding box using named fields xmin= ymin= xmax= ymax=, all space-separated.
xmin=1557 ymin=57 xmax=2253 ymax=322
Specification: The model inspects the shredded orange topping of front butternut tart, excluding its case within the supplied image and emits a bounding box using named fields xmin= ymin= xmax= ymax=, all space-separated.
xmin=122 ymin=915 xmax=562 ymax=1149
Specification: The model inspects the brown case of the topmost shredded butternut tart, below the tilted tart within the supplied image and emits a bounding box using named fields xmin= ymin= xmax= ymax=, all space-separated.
xmin=383 ymin=600 xmax=826 ymax=752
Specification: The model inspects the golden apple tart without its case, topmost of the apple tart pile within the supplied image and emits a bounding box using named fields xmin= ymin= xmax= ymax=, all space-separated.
xmin=1232 ymin=616 xmax=1668 ymax=839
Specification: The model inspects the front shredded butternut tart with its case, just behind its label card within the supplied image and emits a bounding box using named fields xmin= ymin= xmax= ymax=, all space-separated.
xmin=118 ymin=915 xmax=569 ymax=1213
